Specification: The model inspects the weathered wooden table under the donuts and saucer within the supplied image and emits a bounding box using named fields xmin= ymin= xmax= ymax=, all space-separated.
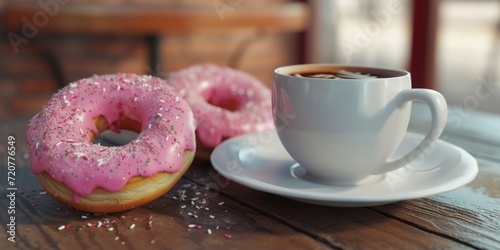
xmin=0 ymin=105 xmax=500 ymax=250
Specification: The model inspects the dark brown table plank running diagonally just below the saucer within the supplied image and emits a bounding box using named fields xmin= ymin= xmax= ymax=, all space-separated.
xmin=187 ymin=161 xmax=476 ymax=249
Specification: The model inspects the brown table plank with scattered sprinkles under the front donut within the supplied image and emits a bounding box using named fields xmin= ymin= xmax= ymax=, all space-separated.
xmin=0 ymin=120 xmax=327 ymax=249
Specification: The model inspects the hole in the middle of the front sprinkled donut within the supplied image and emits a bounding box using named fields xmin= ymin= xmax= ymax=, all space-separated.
xmin=89 ymin=115 xmax=141 ymax=147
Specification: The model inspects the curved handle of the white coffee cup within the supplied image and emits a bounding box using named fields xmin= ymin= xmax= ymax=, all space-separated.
xmin=372 ymin=89 xmax=448 ymax=175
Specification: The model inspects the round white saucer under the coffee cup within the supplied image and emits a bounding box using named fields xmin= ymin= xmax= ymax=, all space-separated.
xmin=211 ymin=131 xmax=478 ymax=207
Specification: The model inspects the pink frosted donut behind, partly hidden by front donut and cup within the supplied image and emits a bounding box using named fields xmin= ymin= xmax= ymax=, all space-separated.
xmin=168 ymin=64 xmax=274 ymax=148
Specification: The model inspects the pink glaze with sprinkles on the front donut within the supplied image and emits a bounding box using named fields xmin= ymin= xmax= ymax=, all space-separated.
xmin=27 ymin=74 xmax=196 ymax=202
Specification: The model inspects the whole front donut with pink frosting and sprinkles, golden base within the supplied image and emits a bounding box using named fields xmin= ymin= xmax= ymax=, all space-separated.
xmin=26 ymin=74 xmax=196 ymax=212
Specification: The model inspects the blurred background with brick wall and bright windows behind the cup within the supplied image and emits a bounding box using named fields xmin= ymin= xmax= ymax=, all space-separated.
xmin=0 ymin=0 xmax=500 ymax=120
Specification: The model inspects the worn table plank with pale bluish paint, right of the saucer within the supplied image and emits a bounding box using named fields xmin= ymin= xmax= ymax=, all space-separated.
xmin=374 ymin=159 xmax=500 ymax=249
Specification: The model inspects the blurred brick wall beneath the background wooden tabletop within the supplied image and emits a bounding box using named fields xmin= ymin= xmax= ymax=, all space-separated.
xmin=0 ymin=0 xmax=299 ymax=120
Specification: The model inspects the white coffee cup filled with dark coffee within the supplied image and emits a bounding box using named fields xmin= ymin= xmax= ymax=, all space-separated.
xmin=272 ymin=64 xmax=448 ymax=185
